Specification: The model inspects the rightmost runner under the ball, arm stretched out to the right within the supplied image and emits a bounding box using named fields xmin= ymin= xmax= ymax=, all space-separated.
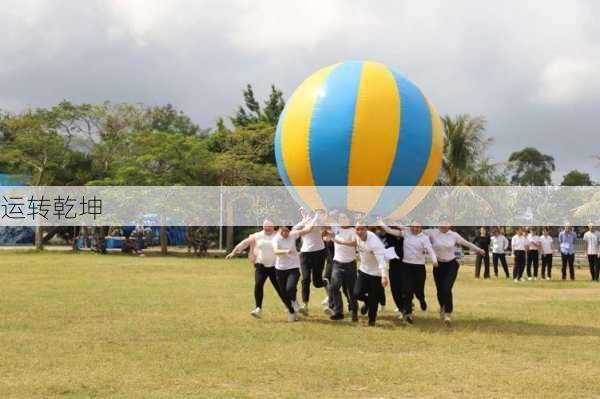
xmin=423 ymin=222 xmax=485 ymax=324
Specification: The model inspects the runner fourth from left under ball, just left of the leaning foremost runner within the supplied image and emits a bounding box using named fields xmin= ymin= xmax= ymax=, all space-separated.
xmin=328 ymin=212 xmax=358 ymax=322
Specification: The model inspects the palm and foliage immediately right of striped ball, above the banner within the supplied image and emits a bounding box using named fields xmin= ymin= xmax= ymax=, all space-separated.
xmin=438 ymin=114 xmax=506 ymax=186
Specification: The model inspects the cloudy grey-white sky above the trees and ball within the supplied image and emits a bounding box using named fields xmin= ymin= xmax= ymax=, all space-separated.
xmin=0 ymin=0 xmax=600 ymax=184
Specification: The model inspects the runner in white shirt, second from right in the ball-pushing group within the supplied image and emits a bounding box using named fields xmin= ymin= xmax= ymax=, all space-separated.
xmin=379 ymin=219 xmax=437 ymax=324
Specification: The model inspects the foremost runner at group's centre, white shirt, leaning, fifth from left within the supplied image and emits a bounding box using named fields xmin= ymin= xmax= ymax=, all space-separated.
xmin=335 ymin=222 xmax=389 ymax=326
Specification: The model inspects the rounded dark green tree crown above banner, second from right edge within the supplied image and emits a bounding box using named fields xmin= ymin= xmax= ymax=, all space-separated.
xmin=508 ymin=147 xmax=556 ymax=186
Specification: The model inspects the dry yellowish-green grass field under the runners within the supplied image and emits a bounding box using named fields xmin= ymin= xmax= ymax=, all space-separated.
xmin=0 ymin=252 xmax=600 ymax=398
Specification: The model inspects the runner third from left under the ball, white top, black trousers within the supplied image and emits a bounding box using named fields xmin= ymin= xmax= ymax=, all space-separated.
xmin=292 ymin=208 xmax=327 ymax=315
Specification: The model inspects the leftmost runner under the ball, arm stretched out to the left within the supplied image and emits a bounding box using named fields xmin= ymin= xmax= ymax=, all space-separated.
xmin=225 ymin=219 xmax=283 ymax=319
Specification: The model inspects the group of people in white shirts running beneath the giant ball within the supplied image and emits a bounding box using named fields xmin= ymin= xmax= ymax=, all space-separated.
xmin=227 ymin=210 xmax=485 ymax=325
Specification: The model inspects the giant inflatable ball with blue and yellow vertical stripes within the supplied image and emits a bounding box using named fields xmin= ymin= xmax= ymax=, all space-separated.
xmin=275 ymin=61 xmax=443 ymax=217
